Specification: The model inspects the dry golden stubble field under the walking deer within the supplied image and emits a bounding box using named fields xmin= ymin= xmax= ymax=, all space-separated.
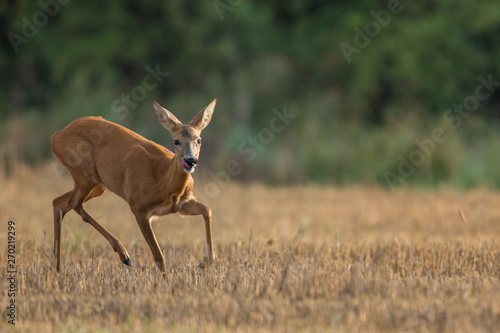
xmin=0 ymin=166 xmax=500 ymax=332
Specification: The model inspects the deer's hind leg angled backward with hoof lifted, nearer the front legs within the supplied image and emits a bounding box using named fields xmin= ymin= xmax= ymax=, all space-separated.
xmin=68 ymin=184 xmax=133 ymax=266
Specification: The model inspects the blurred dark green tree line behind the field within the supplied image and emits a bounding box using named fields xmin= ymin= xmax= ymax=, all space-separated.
xmin=0 ymin=0 xmax=500 ymax=187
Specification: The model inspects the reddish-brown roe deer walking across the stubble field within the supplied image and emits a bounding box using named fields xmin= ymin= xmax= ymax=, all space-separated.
xmin=52 ymin=100 xmax=216 ymax=272
